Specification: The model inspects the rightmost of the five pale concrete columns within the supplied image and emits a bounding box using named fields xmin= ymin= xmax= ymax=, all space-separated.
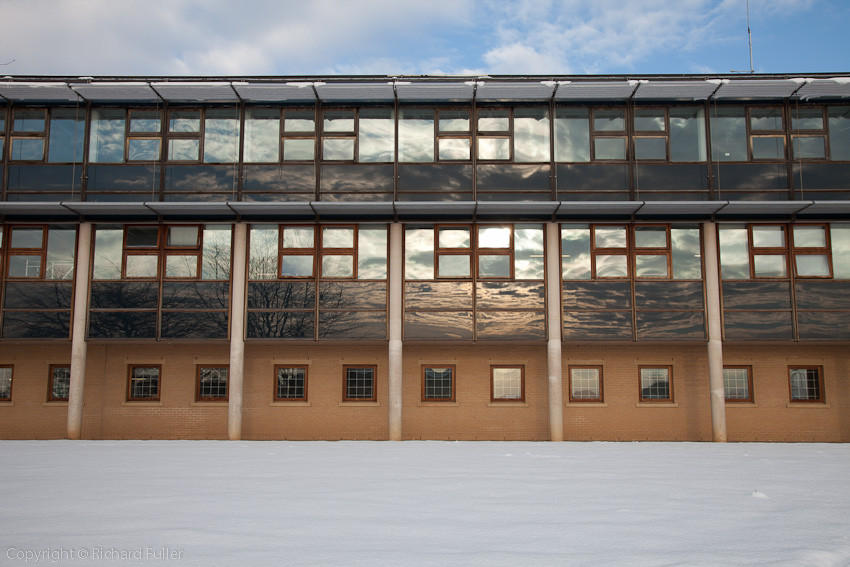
xmin=702 ymin=222 xmax=726 ymax=443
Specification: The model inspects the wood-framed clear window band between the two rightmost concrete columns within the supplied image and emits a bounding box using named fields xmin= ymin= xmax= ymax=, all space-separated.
xmin=561 ymin=224 xmax=702 ymax=280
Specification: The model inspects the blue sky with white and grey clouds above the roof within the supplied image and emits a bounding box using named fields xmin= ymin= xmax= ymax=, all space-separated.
xmin=0 ymin=0 xmax=850 ymax=76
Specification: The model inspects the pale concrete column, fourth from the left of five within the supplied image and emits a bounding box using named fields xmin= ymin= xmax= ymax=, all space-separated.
xmin=546 ymin=222 xmax=564 ymax=441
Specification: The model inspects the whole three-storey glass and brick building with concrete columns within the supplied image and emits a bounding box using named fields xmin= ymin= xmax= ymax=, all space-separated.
xmin=0 ymin=74 xmax=850 ymax=442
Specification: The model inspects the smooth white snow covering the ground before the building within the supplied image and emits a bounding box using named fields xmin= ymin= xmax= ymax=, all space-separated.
xmin=0 ymin=441 xmax=850 ymax=567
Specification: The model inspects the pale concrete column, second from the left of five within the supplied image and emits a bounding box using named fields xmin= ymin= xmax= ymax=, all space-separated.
xmin=227 ymin=223 xmax=248 ymax=441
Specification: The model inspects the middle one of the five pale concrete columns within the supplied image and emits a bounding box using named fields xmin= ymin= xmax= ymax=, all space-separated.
xmin=388 ymin=223 xmax=404 ymax=441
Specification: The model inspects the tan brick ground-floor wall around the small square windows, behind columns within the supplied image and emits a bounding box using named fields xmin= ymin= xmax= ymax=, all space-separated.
xmin=0 ymin=342 xmax=850 ymax=442
